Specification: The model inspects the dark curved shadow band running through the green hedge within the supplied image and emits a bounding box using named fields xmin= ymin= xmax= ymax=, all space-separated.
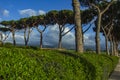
xmin=59 ymin=51 xmax=96 ymax=80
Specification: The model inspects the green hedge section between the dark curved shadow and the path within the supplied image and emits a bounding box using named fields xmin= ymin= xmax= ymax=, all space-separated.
xmin=82 ymin=53 xmax=118 ymax=80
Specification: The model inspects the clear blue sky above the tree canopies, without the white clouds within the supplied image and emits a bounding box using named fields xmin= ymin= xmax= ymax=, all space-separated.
xmin=0 ymin=0 xmax=72 ymax=20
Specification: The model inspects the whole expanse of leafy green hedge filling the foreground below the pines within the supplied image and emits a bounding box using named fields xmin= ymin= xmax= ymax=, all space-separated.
xmin=0 ymin=48 xmax=117 ymax=80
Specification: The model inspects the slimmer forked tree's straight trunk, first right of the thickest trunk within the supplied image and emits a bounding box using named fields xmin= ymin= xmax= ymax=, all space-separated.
xmin=95 ymin=12 xmax=102 ymax=54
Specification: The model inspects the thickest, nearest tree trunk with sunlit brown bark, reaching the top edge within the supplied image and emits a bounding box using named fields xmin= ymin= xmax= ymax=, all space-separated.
xmin=72 ymin=0 xmax=83 ymax=53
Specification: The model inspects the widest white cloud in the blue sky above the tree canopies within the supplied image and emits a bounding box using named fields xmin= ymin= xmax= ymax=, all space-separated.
xmin=19 ymin=9 xmax=37 ymax=16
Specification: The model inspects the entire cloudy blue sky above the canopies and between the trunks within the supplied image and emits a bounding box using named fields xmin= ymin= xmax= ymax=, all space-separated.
xmin=0 ymin=0 xmax=104 ymax=48
